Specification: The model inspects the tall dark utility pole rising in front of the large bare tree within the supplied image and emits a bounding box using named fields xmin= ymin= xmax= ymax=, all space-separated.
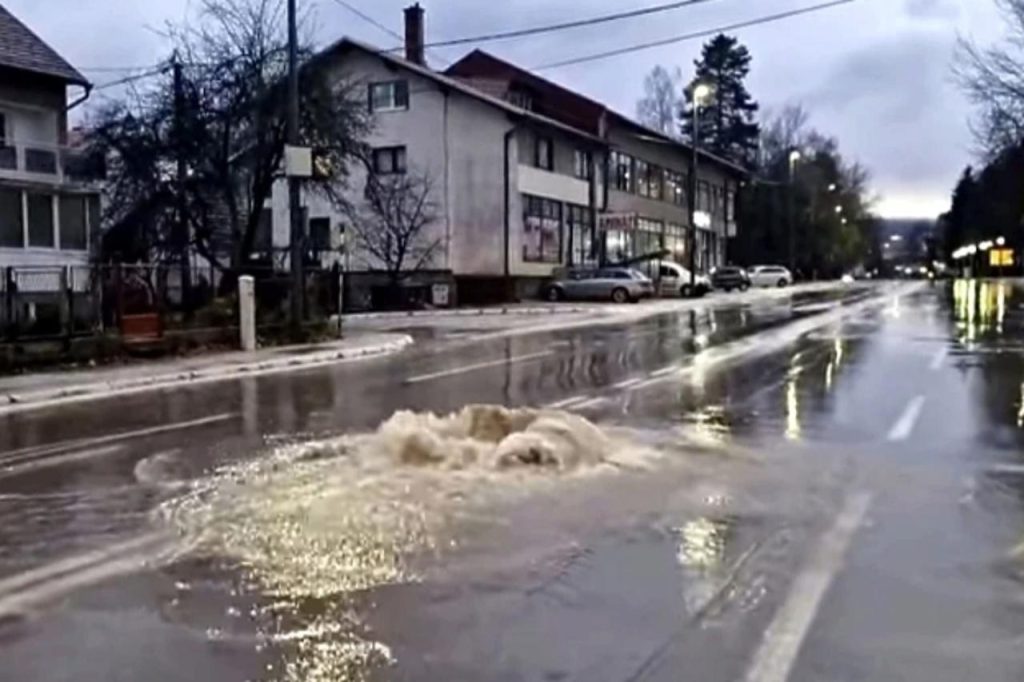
xmin=287 ymin=0 xmax=305 ymax=340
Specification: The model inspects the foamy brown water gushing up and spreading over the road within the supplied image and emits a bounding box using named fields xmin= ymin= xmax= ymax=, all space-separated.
xmin=155 ymin=406 xmax=656 ymax=680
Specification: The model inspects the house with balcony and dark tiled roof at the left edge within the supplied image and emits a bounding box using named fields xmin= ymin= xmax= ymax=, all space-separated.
xmin=0 ymin=6 xmax=99 ymax=267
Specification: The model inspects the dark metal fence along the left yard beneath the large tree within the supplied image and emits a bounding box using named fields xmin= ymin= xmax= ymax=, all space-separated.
xmin=0 ymin=264 xmax=339 ymax=360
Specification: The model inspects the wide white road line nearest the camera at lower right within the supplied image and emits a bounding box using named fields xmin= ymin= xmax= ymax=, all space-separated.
xmin=743 ymin=493 xmax=871 ymax=682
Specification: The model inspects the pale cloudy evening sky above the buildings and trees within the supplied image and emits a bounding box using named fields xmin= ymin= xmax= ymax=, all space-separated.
xmin=6 ymin=0 xmax=1002 ymax=217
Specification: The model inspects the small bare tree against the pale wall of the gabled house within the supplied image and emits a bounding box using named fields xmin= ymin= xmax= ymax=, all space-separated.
xmin=349 ymin=169 xmax=443 ymax=291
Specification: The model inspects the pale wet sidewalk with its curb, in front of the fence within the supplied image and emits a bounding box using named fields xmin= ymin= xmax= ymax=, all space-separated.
xmin=0 ymin=333 xmax=413 ymax=417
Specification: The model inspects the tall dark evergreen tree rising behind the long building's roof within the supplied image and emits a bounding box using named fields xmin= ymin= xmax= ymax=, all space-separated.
xmin=682 ymin=34 xmax=760 ymax=168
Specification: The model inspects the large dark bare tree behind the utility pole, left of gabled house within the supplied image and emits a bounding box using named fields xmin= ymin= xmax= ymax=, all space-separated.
xmin=93 ymin=0 xmax=369 ymax=271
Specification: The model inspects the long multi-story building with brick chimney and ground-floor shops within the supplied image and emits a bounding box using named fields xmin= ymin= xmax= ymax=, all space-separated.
xmin=267 ymin=5 xmax=744 ymax=306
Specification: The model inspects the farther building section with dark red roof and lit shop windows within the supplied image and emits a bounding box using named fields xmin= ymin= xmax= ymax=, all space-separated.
xmin=445 ymin=50 xmax=746 ymax=273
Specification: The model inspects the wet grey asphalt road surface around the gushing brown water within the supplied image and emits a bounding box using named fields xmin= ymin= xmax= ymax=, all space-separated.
xmin=0 ymin=282 xmax=1024 ymax=682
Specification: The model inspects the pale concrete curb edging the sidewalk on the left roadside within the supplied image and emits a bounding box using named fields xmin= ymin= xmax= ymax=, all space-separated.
xmin=0 ymin=335 xmax=414 ymax=415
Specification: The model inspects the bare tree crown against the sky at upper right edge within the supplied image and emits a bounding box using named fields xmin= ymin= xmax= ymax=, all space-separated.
xmin=953 ymin=0 xmax=1024 ymax=157
